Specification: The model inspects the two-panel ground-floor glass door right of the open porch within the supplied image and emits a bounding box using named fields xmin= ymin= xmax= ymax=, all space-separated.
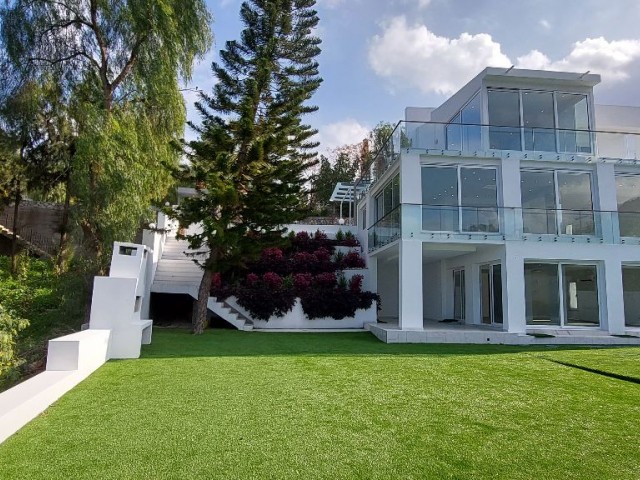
xmin=524 ymin=262 xmax=600 ymax=326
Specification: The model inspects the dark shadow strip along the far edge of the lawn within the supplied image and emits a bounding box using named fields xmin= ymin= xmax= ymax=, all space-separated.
xmin=142 ymin=328 xmax=615 ymax=359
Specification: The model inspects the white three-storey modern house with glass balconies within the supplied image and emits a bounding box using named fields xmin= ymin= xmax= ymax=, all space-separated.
xmin=356 ymin=68 xmax=640 ymax=342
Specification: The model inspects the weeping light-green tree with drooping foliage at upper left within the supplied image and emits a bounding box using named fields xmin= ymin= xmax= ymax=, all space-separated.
xmin=0 ymin=0 xmax=212 ymax=266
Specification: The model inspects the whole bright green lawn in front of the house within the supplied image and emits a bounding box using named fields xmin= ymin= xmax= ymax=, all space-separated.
xmin=0 ymin=329 xmax=640 ymax=480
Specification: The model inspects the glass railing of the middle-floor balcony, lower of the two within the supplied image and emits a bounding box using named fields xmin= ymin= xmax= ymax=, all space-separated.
xmin=369 ymin=204 xmax=640 ymax=251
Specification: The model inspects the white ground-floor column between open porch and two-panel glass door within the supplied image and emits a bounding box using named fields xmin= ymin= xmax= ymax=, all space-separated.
xmin=502 ymin=248 xmax=527 ymax=333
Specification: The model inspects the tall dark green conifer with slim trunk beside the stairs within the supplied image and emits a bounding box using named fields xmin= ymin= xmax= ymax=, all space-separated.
xmin=177 ymin=0 xmax=322 ymax=333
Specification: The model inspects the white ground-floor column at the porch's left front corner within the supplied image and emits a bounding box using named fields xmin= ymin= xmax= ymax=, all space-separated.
xmin=398 ymin=240 xmax=423 ymax=330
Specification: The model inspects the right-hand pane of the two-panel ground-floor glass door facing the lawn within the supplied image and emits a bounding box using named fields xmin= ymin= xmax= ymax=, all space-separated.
xmin=562 ymin=265 xmax=600 ymax=326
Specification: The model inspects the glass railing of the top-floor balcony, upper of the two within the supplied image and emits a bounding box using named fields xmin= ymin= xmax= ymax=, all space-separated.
xmin=355 ymin=121 xmax=640 ymax=202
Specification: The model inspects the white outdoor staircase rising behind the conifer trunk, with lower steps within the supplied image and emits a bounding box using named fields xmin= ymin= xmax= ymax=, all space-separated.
xmin=151 ymin=236 xmax=253 ymax=331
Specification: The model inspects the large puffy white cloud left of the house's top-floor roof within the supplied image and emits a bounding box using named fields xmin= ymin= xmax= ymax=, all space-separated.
xmin=369 ymin=16 xmax=511 ymax=94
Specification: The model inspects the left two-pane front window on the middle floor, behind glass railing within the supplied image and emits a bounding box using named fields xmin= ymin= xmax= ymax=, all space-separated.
xmin=422 ymin=166 xmax=499 ymax=232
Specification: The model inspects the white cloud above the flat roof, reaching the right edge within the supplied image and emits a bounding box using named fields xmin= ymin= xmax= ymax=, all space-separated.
xmin=517 ymin=37 xmax=640 ymax=82
